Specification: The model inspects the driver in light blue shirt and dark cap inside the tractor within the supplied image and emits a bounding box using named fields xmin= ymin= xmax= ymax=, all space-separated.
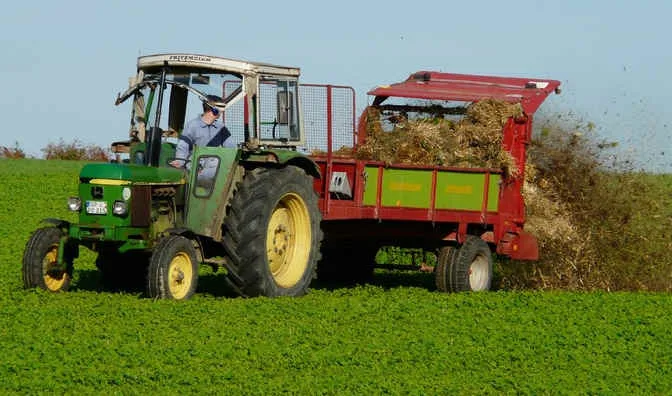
xmin=170 ymin=95 xmax=236 ymax=168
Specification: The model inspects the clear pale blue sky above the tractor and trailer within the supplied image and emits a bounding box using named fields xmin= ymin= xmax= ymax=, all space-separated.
xmin=0 ymin=0 xmax=672 ymax=172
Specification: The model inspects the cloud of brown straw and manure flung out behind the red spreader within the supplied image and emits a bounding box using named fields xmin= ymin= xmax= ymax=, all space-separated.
xmin=499 ymin=117 xmax=672 ymax=291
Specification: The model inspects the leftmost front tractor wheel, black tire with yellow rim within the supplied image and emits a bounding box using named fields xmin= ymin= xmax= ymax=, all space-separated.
xmin=22 ymin=227 xmax=73 ymax=292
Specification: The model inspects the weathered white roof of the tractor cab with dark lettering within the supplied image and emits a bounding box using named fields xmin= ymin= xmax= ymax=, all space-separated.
xmin=138 ymin=53 xmax=300 ymax=77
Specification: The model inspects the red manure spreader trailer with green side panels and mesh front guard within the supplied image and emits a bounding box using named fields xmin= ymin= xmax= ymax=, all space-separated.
xmin=302 ymin=71 xmax=560 ymax=291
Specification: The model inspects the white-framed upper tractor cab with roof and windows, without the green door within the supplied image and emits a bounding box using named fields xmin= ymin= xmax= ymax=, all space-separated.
xmin=113 ymin=54 xmax=303 ymax=166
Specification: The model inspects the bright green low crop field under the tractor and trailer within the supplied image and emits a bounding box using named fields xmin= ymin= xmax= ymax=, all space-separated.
xmin=0 ymin=160 xmax=672 ymax=395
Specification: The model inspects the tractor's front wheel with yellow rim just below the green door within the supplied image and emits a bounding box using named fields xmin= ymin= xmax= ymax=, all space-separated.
xmin=147 ymin=235 xmax=198 ymax=300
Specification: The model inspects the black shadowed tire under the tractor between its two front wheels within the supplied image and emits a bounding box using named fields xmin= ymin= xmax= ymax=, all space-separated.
xmin=96 ymin=248 xmax=149 ymax=291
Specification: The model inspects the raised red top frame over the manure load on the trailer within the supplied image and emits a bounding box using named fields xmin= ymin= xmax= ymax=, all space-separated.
xmin=368 ymin=71 xmax=560 ymax=114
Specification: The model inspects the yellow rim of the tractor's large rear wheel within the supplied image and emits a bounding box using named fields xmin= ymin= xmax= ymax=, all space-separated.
xmin=266 ymin=193 xmax=312 ymax=288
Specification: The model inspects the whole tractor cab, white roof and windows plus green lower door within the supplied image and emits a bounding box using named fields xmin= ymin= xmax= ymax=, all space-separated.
xmin=105 ymin=54 xmax=310 ymax=239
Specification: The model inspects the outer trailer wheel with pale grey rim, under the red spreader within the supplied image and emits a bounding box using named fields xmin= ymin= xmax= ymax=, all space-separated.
xmin=447 ymin=235 xmax=492 ymax=292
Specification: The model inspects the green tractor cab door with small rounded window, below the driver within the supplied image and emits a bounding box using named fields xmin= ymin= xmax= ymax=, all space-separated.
xmin=184 ymin=146 xmax=239 ymax=240
